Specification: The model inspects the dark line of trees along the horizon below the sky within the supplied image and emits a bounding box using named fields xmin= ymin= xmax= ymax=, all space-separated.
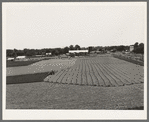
xmin=6 ymin=42 xmax=144 ymax=57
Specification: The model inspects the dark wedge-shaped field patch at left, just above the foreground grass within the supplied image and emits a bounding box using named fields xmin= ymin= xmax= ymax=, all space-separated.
xmin=6 ymin=72 xmax=49 ymax=84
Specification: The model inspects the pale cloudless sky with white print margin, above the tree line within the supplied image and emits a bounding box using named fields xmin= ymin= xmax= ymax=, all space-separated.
xmin=2 ymin=2 xmax=147 ymax=49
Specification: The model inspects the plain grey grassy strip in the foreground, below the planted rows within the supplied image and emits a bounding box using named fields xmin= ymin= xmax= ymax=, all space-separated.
xmin=6 ymin=82 xmax=144 ymax=110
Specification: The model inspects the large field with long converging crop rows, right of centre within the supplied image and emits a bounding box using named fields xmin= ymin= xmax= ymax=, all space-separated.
xmin=44 ymin=56 xmax=144 ymax=87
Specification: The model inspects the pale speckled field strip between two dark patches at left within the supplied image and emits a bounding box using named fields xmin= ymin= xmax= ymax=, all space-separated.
xmin=6 ymin=59 xmax=76 ymax=76
